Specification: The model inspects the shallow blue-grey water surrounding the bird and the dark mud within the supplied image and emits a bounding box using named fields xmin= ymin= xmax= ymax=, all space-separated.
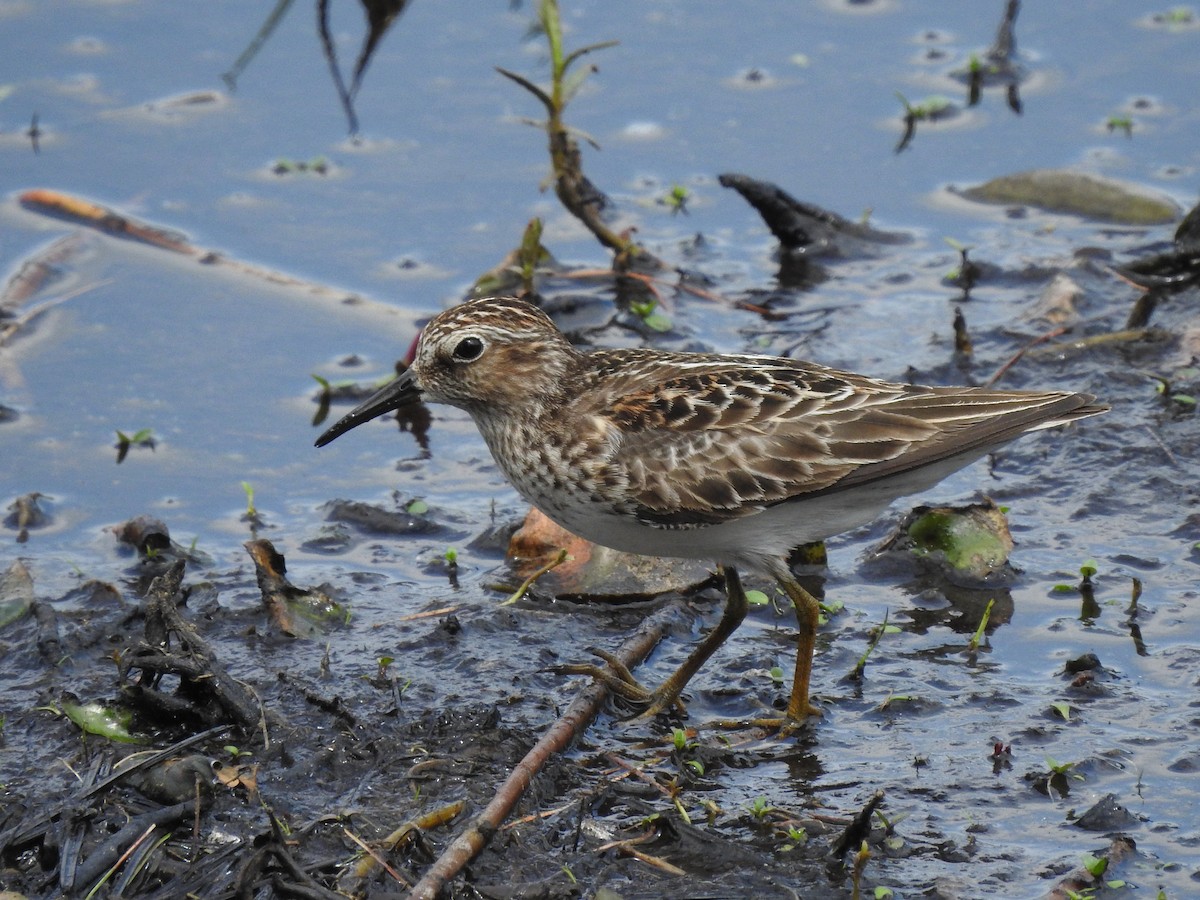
xmin=0 ymin=0 xmax=1200 ymax=900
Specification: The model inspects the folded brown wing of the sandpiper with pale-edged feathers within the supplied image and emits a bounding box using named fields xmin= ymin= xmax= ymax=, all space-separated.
xmin=593 ymin=352 xmax=1103 ymax=528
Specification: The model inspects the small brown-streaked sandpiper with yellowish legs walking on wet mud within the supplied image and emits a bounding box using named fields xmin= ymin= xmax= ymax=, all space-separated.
xmin=316 ymin=296 xmax=1109 ymax=731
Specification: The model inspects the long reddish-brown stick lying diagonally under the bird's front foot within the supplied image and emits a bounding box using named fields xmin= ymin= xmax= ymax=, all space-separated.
xmin=409 ymin=604 xmax=674 ymax=900
